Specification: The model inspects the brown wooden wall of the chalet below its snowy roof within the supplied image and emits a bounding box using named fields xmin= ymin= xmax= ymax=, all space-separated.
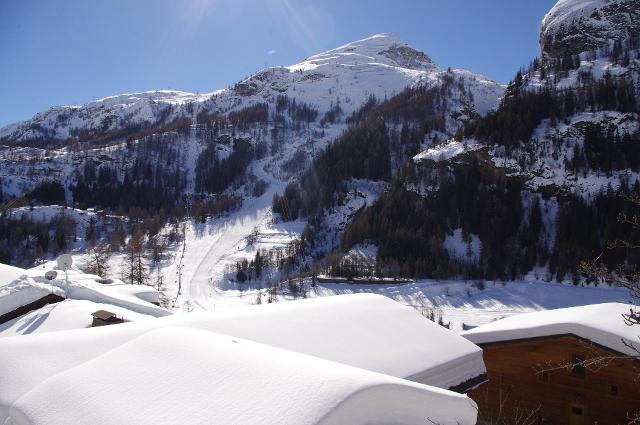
xmin=469 ymin=335 xmax=640 ymax=425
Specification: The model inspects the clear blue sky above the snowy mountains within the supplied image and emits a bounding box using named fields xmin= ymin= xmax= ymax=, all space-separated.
xmin=0 ymin=0 xmax=555 ymax=126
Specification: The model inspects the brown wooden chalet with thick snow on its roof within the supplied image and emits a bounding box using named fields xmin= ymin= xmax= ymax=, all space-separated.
xmin=462 ymin=304 xmax=640 ymax=425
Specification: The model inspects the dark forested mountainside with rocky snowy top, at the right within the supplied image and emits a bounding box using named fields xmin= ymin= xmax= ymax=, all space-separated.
xmin=342 ymin=0 xmax=640 ymax=283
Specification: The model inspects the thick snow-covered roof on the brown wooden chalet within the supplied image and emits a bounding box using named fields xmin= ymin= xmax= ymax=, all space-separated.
xmin=461 ymin=303 xmax=640 ymax=355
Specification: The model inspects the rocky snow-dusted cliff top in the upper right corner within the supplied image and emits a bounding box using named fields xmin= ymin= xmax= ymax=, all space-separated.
xmin=540 ymin=0 xmax=640 ymax=58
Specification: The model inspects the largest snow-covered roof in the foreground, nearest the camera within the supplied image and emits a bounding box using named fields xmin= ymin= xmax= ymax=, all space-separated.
xmin=0 ymin=326 xmax=477 ymax=425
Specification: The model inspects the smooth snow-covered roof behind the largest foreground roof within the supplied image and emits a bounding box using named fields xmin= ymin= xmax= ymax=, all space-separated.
xmin=154 ymin=294 xmax=485 ymax=388
